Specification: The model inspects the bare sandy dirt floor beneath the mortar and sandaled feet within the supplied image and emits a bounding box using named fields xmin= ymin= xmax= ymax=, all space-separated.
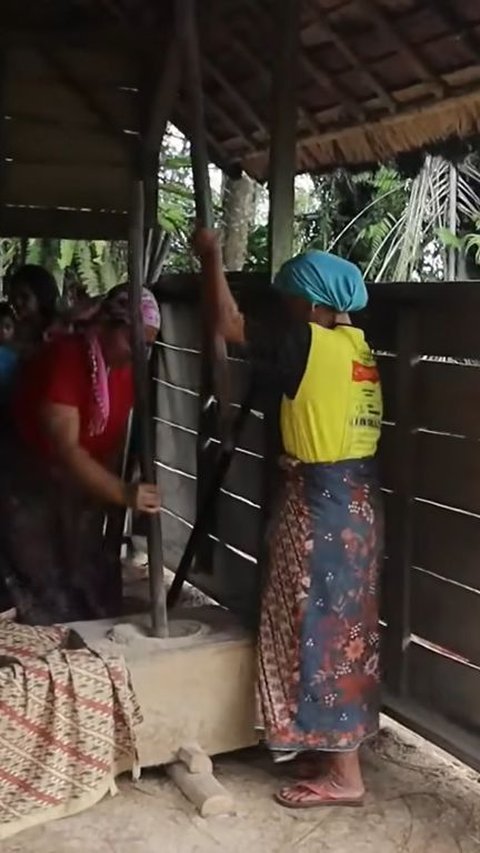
xmin=0 ymin=721 xmax=480 ymax=853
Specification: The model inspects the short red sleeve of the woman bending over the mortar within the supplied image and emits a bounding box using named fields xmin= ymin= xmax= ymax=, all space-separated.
xmin=43 ymin=336 xmax=88 ymax=409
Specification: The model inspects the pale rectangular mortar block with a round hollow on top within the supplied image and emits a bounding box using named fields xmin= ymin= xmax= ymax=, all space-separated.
xmin=71 ymin=607 xmax=258 ymax=767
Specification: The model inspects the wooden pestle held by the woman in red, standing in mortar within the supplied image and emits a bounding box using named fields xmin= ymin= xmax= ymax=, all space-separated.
xmin=128 ymin=180 xmax=168 ymax=637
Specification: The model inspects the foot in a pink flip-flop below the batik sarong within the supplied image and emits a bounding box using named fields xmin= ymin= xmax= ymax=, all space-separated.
xmin=275 ymin=776 xmax=365 ymax=809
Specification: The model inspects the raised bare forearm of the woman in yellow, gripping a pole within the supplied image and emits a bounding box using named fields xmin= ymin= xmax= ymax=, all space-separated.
xmin=192 ymin=228 xmax=245 ymax=344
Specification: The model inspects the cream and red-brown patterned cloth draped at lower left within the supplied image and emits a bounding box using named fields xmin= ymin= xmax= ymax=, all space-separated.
xmin=0 ymin=621 xmax=141 ymax=839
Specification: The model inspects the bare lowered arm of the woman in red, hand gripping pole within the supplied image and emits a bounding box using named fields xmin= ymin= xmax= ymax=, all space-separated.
xmin=42 ymin=403 xmax=160 ymax=513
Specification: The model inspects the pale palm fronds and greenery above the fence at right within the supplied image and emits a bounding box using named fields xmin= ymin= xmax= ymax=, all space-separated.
xmin=329 ymin=155 xmax=480 ymax=281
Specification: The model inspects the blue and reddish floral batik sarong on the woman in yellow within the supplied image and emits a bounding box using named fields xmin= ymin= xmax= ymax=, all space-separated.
xmin=259 ymin=460 xmax=383 ymax=752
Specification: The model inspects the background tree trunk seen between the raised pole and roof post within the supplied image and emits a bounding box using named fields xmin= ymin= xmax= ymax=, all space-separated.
xmin=222 ymin=175 xmax=255 ymax=271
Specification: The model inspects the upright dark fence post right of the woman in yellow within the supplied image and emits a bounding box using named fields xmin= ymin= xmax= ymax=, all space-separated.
xmin=384 ymin=305 xmax=418 ymax=695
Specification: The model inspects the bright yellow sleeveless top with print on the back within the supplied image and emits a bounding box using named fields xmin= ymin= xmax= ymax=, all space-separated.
xmin=280 ymin=324 xmax=382 ymax=462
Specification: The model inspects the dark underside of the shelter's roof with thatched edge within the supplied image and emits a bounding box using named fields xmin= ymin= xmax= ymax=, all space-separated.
xmin=0 ymin=0 xmax=480 ymax=233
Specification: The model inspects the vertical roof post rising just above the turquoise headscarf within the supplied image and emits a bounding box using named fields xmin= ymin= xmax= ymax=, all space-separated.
xmin=269 ymin=0 xmax=301 ymax=279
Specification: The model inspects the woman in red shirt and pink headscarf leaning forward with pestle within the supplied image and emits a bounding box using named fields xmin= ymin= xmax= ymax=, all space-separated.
xmin=0 ymin=286 xmax=160 ymax=624
